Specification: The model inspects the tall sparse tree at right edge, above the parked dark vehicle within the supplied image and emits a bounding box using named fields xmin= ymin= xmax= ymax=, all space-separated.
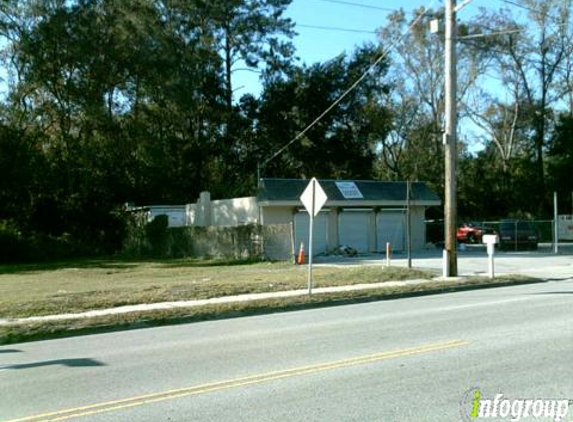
xmin=470 ymin=0 xmax=573 ymax=214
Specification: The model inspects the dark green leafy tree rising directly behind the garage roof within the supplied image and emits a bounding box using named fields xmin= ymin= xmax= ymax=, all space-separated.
xmin=257 ymin=45 xmax=389 ymax=179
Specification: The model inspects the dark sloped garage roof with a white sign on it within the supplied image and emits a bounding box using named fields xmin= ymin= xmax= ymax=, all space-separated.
xmin=257 ymin=179 xmax=441 ymax=207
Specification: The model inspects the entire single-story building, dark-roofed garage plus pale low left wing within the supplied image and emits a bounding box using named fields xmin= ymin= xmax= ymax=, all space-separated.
xmin=132 ymin=179 xmax=441 ymax=255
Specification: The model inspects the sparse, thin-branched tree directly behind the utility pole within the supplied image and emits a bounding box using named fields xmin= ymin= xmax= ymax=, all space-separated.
xmin=379 ymin=8 xmax=490 ymax=178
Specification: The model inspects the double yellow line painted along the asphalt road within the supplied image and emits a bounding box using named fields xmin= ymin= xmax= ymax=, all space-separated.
xmin=6 ymin=340 xmax=469 ymax=422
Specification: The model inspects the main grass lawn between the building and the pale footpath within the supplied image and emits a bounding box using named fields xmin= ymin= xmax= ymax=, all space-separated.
xmin=0 ymin=259 xmax=433 ymax=318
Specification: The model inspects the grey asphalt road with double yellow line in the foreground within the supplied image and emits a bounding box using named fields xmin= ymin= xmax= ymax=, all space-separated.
xmin=0 ymin=279 xmax=573 ymax=422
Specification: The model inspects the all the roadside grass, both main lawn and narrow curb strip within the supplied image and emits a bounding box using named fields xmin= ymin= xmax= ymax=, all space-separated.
xmin=0 ymin=259 xmax=537 ymax=344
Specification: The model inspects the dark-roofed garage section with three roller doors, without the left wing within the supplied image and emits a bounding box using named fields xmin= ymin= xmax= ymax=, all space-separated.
xmin=257 ymin=179 xmax=441 ymax=254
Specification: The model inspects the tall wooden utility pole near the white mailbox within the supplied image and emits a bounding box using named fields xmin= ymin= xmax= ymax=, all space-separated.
xmin=444 ymin=0 xmax=458 ymax=277
